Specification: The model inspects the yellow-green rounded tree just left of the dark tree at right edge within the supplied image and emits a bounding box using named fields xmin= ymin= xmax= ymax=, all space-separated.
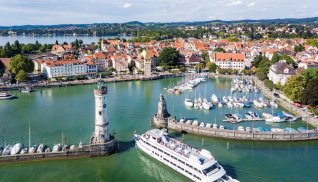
xmin=283 ymin=75 xmax=306 ymax=102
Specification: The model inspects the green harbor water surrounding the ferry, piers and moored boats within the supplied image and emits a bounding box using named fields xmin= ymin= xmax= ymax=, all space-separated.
xmin=0 ymin=78 xmax=318 ymax=182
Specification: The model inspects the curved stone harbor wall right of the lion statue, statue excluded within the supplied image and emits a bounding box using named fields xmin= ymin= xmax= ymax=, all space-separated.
xmin=168 ymin=120 xmax=318 ymax=141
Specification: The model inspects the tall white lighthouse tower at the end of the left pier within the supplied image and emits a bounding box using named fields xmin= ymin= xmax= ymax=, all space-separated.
xmin=91 ymin=80 xmax=110 ymax=144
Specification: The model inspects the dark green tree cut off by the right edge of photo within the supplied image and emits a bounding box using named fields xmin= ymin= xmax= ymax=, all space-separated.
xmin=302 ymin=79 xmax=318 ymax=106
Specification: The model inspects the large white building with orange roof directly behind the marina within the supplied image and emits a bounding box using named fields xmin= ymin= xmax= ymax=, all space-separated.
xmin=210 ymin=52 xmax=246 ymax=70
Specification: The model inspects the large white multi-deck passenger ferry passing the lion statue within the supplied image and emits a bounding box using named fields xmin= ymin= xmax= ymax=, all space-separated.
xmin=134 ymin=129 xmax=238 ymax=182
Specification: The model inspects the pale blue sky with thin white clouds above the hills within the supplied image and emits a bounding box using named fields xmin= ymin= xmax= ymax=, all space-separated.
xmin=0 ymin=0 xmax=318 ymax=26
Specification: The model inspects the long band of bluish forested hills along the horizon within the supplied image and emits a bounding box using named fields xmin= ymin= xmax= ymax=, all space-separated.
xmin=0 ymin=17 xmax=318 ymax=36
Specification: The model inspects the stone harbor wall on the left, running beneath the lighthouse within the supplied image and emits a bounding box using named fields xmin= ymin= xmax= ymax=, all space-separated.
xmin=0 ymin=140 xmax=118 ymax=163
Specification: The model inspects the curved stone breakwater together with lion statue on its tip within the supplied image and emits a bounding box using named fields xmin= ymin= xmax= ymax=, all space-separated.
xmin=152 ymin=95 xmax=318 ymax=141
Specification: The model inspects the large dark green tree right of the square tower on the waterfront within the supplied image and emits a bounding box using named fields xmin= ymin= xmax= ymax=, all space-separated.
xmin=159 ymin=47 xmax=181 ymax=68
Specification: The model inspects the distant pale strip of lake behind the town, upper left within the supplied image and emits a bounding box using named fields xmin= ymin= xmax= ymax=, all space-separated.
xmin=0 ymin=36 xmax=131 ymax=46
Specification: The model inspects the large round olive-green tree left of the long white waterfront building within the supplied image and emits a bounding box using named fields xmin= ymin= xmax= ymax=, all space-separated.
xmin=9 ymin=54 xmax=34 ymax=75
